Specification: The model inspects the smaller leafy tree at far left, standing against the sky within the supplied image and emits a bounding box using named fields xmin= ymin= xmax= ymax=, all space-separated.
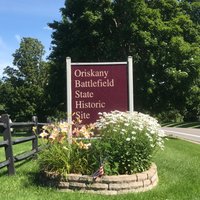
xmin=0 ymin=38 xmax=48 ymax=120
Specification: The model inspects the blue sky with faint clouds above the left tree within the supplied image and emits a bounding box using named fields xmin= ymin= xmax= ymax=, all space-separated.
xmin=0 ymin=0 xmax=65 ymax=77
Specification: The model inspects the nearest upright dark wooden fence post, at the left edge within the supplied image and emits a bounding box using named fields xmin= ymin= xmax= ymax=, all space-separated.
xmin=1 ymin=114 xmax=15 ymax=175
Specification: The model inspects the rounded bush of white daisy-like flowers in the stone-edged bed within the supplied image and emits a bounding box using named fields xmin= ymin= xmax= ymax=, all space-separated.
xmin=95 ymin=111 xmax=164 ymax=174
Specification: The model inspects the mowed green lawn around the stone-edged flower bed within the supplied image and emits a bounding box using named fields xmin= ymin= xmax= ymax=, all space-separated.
xmin=0 ymin=139 xmax=200 ymax=200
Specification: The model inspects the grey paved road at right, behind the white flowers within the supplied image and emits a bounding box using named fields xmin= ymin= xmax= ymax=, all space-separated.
xmin=162 ymin=127 xmax=200 ymax=143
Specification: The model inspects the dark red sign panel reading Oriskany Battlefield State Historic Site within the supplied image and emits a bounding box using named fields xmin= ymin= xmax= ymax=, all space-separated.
xmin=71 ymin=64 xmax=128 ymax=124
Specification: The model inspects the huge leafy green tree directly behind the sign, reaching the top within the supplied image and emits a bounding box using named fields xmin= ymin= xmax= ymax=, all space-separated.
xmin=49 ymin=0 xmax=200 ymax=119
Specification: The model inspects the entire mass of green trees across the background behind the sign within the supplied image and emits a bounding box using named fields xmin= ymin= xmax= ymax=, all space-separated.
xmin=0 ymin=0 xmax=200 ymax=121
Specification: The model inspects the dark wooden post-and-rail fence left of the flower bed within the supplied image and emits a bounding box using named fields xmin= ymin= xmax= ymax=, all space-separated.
xmin=0 ymin=114 xmax=44 ymax=175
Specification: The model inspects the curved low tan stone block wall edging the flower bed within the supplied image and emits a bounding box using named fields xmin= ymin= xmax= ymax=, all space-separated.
xmin=45 ymin=163 xmax=158 ymax=195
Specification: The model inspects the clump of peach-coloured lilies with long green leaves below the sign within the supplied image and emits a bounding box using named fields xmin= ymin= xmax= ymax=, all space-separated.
xmin=38 ymin=119 xmax=93 ymax=174
